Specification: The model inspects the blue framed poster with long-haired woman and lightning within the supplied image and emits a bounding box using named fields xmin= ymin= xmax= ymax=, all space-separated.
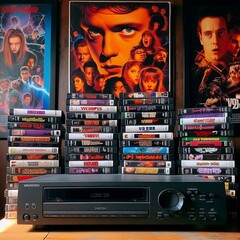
xmin=0 ymin=0 xmax=57 ymax=138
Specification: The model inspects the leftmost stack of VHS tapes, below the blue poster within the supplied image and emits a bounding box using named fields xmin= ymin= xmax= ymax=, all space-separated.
xmin=5 ymin=109 xmax=62 ymax=218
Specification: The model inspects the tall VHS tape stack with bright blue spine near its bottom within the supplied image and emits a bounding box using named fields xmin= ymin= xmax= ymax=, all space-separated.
xmin=119 ymin=92 xmax=175 ymax=174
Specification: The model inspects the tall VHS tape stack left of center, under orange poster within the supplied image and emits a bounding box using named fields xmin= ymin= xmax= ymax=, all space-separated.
xmin=65 ymin=93 xmax=118 ymax=174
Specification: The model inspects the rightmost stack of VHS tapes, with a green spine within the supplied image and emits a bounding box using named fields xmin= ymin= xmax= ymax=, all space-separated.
xmin=178 ymin=107 xmax=237 ymax=214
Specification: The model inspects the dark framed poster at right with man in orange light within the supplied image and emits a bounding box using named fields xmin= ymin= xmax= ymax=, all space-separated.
xmin=183 ymin=0 xmax=240 ymax=110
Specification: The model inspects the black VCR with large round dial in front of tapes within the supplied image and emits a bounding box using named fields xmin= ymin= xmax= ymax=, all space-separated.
xmin=17 ymin=174 xmax=227 ymax=225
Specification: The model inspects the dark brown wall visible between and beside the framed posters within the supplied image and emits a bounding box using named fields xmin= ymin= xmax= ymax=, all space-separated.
xmin=0 ymin=0 xmax=191 ymax=219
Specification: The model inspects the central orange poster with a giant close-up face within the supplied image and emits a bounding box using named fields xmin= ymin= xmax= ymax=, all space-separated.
xmin=69 ymin=1 xmax=172 ymax=98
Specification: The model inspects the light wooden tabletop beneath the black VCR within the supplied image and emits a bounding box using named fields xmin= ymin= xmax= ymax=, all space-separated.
xmin=0 ymin=219 xmax=240 ymax=240
